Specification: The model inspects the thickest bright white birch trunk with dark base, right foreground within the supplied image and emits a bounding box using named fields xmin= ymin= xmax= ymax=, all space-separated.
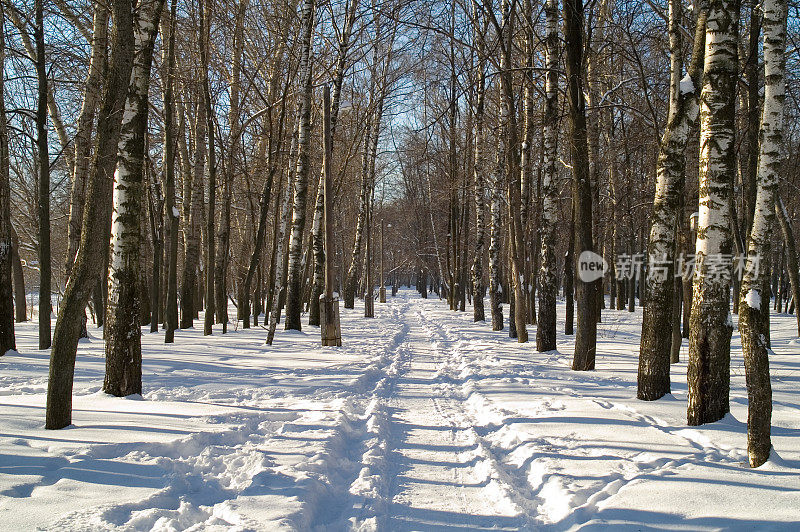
xmin=686 ymin=0 xmax=739 ymax=425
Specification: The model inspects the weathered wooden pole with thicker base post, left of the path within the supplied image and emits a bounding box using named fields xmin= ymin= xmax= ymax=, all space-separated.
xmin=320 ymin=85 xmax=342 ymax=346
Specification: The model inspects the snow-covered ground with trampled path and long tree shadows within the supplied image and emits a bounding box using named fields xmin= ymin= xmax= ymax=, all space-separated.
xmin=0 ymin=290 xmax=800 ymax=530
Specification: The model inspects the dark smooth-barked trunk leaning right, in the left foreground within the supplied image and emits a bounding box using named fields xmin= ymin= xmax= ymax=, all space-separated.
xmin=45 ymin=0 xmax=134 ymax=429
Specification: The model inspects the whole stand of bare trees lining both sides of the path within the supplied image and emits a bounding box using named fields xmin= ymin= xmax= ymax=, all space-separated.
xmin=0 ymin=0 xmax=800 ymax=465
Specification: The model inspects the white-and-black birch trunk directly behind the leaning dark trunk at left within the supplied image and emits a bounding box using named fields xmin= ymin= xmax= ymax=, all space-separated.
xmin=103 ymin=0 xmax=165 ymax=397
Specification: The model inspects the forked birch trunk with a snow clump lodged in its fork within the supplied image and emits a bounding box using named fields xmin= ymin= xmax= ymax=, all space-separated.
xmin=637 ymin=0 xmax=705 ymax=401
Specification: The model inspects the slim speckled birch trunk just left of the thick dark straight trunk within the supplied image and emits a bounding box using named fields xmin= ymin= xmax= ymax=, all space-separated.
xmin=536 ymin=0 xmax=558 ymax=351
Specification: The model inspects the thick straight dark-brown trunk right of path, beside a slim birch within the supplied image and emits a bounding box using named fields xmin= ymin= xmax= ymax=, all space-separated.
xmin=564 ymin=0 xmax=599 ymax=371
